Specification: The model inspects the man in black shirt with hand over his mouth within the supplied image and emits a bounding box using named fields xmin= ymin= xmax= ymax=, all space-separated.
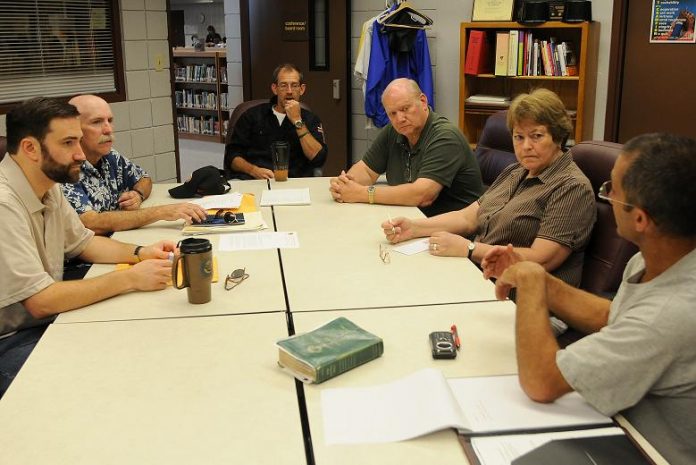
xmin=224 ymin=63 xmax=328 ymax=179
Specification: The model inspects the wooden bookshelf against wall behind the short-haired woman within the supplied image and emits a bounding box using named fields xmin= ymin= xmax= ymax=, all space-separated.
xmin=459 ymin=21 xmax=591 ymax=144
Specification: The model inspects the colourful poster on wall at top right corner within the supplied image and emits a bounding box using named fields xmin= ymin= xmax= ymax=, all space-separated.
xmin=650 ymin=0 xmax=696 ymax=44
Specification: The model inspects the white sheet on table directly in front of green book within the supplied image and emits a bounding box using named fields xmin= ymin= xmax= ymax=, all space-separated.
xmin=321 ymin=368 xmax=463 ymax=444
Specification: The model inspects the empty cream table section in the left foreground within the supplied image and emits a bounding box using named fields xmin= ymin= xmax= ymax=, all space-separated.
xmin=0 ymin=313 xmax=306 ymax=465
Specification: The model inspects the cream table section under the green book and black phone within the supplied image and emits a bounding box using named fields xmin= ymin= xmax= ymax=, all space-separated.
xmin=293 ymin=301 xmax=517 ymax=465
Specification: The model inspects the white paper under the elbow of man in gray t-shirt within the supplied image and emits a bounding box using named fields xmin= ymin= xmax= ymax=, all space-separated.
xmin=448 ymin=375 xmax=611 ymax=433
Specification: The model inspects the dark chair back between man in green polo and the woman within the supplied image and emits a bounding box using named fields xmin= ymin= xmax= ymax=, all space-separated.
xmin=474 ymin=110 xmax=517 ymax=186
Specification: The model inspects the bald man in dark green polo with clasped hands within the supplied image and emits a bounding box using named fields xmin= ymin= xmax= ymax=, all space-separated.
xmin=329 ymin=78 xmax=483 ymax=216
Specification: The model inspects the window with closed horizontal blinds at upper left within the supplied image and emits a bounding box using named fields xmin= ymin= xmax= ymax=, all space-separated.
xmin=0 ymin=0 xmax=125 ymax=109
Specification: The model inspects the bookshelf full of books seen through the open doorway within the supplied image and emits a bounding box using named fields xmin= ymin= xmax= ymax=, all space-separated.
xmin=173 ymin=48 xmax=229 ymax=143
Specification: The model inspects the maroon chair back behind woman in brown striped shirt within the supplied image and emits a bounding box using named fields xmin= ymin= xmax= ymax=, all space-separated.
xmin=570 ymin=141 xmax=638 ymax=296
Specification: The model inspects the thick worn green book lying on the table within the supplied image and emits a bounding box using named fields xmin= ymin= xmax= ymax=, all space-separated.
xmin=276 ymin=317 xmax=384 ymax=384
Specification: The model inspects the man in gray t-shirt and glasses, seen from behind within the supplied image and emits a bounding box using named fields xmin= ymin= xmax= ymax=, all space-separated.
xmin=483 ymin=134 xmax=696 ymax=464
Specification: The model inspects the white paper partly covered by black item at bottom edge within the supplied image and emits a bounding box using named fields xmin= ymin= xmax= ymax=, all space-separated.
xmin=471 ymin=427 xmax=624 ymax=465
